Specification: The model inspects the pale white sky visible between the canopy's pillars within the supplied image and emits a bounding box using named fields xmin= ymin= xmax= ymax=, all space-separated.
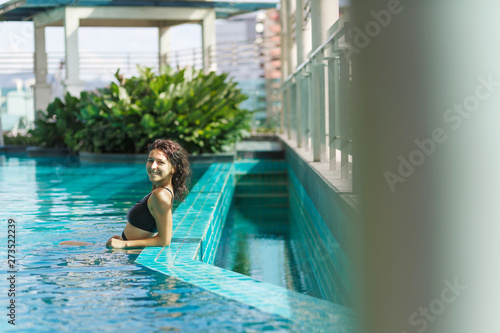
xmin=0 ymin=0 xmax=278 ymax=52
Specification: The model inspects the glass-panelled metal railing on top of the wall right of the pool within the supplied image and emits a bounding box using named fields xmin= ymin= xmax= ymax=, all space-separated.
xmin=281 ymin=14 xmax=352 ymax=178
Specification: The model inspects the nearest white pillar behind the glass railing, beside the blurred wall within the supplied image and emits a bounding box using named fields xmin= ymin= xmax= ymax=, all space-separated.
xmin=311 ymin=0 xmax=339 ymax=162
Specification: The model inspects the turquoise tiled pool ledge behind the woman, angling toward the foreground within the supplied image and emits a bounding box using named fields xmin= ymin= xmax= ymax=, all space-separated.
xmin=136 ymin=160 xmax=353 ymax=332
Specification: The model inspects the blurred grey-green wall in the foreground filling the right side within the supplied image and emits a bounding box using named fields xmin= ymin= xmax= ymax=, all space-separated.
xmin=351 ymin=0 xmax=500 ymax=333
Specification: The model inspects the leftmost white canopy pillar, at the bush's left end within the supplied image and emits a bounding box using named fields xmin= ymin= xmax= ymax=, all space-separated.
xmin=34 ymin=26 xmax=51 ymax=119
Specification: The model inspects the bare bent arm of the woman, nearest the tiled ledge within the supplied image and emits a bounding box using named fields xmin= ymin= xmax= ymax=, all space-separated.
xmin=106 ymin=188 xmax=173 ymax=249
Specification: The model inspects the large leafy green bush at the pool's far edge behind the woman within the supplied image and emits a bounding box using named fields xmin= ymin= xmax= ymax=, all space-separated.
xmin=34 ymin=68 xmax=251 ymax=154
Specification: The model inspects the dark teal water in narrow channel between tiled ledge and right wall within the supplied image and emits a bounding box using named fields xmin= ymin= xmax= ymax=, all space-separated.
xmin=214 ymin=170 xmax=321 ymax=298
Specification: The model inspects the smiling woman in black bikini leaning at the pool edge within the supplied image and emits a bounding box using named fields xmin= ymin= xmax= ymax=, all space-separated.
xmin=106 ymin=139 xmax=191 ymax=249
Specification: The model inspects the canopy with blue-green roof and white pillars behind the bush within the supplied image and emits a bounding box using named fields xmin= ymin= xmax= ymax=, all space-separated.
xmin=0 ymin=0 xmax=276 ymax=110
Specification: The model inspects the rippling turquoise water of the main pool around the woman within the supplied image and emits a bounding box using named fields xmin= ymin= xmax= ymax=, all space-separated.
xmin=0 ymin=155 xmax=302 ymax=332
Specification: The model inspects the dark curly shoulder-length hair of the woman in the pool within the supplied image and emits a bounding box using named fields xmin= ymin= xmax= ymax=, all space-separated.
xmin=148 ymin=139 xmax=191 ymax=201
